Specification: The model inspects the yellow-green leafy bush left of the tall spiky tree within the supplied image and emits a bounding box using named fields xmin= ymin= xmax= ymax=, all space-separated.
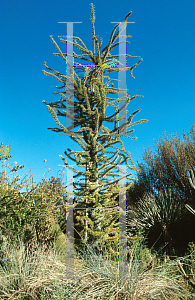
xmin=0 ymin=144 xmax=68 ymax=252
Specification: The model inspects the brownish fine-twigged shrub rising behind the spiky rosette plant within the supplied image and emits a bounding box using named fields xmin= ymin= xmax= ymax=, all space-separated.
xmin=128 ymin=126 xmax=195 ymax=203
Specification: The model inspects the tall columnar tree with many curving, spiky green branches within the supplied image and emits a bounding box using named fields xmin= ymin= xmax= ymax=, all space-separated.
xmin=43 ymin=4 xmax=147 ymax=253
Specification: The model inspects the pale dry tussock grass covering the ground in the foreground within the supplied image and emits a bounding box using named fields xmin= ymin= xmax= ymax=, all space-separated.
xmin=0 ymin=229 xmax=195 ymax=300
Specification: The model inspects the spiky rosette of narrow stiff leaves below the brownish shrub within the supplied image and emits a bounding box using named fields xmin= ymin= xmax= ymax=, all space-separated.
xmin=127 ymin=188 xmax=188 ymax=253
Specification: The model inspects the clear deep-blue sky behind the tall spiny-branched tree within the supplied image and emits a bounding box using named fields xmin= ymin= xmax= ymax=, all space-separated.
xmin=0 ymin=0 xmax=195 ymax=192
